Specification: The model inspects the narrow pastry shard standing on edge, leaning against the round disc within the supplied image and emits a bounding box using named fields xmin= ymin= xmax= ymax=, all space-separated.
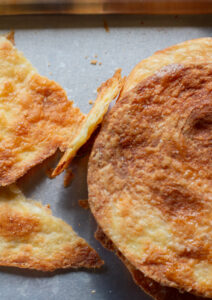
xmin=52 ymin=69 xmax=124 ymax=177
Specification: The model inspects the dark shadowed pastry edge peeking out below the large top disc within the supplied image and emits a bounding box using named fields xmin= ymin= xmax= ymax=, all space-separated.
xmin=95 ymin=227 xmax=205 ymax=300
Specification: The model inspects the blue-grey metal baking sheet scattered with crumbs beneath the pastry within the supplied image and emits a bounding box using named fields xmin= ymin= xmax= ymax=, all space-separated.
xmin=0 ymin=15 xmax=212 ymax=300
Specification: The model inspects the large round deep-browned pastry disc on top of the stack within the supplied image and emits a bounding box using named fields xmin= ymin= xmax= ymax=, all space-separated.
xmin=88 ymin=64 xmax=212 ymax=297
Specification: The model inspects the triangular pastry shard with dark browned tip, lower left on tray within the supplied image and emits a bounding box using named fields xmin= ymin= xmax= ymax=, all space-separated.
xmin=0 ymin=186 xmax=103 ymax=271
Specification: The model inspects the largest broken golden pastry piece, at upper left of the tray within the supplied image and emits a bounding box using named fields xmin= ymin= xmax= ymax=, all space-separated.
xmin=0 ymin=36 xmax=84 ymax=186
